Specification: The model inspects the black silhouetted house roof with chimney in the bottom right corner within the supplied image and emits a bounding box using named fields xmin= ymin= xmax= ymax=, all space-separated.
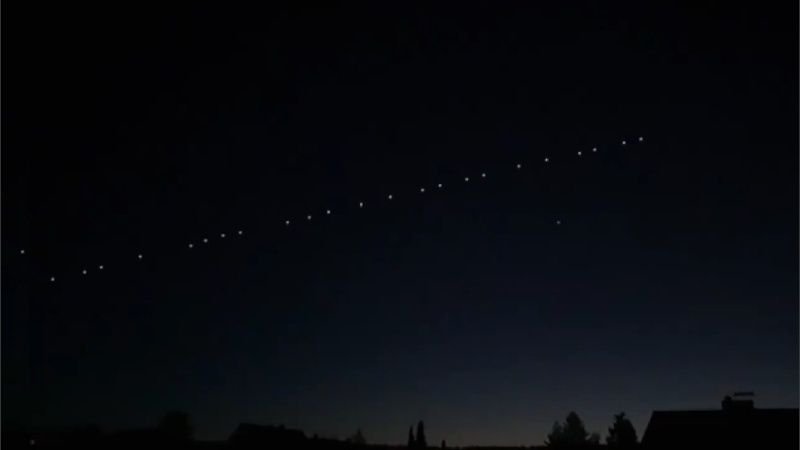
xmin=642 ymin=392 xmax=799 ymax=449
